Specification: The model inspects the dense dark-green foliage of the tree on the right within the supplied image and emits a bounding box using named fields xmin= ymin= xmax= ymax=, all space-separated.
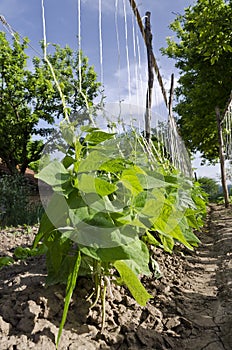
xmin=162 ymin=0 xmax=232 ymax=162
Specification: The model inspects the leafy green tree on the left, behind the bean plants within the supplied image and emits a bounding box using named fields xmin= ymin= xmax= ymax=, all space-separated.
xmin=0 ymin=32 xmax=100 ymax=174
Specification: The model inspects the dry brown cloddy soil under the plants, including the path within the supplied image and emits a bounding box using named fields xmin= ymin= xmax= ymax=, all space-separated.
xmin=0 ymin=205 xmax=232 ymax=350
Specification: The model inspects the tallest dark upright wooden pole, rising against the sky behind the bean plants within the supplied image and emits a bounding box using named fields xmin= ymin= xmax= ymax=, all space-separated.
xmin=145 ymin=12 xmax=154 ymax=143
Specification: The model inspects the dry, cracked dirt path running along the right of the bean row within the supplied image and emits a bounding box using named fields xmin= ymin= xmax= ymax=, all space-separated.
xmin=165 ymin=206 xmax=232 ymax=350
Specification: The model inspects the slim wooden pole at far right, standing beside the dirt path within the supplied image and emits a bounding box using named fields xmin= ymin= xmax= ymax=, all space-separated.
xmin=215 ymin=107 xmax=230 ymax=208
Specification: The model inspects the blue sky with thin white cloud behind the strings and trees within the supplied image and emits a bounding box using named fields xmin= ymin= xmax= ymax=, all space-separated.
xmin=0 ymin=0 xmax=219 ymax=177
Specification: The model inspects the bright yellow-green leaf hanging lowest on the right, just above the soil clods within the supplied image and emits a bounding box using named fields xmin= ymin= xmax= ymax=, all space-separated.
xmin=114 ymin=261 xmax=153 ymax=306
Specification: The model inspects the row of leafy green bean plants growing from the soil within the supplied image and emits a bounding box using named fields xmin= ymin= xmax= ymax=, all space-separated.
xmin=29 ymin=120 xmax=206 ymax=347
